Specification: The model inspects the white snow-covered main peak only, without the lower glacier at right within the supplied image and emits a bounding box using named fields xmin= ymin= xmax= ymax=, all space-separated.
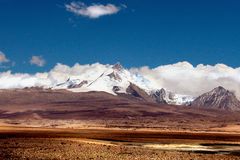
xmin=53 ymin=63 xmax=151 ymax=95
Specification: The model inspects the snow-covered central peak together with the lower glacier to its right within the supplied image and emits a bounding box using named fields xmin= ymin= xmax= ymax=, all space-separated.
xmin=53 ymin=63 xmax=193 ymax=105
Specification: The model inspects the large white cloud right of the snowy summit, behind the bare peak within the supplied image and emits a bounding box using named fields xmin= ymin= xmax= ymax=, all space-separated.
xmin=131 ymin=62 xmax=240 ymax=97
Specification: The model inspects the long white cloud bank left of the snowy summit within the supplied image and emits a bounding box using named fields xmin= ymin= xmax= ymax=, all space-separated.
xmin=0 ymin=63 xmax=109 ymax=89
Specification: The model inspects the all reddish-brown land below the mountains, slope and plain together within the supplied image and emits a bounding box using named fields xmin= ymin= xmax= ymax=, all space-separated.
xmin=0 ymin=88 xmax=240 ymax=159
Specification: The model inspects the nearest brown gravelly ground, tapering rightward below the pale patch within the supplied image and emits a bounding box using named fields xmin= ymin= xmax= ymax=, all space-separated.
xmin=0 ymin=138 xmax=240 ymax=160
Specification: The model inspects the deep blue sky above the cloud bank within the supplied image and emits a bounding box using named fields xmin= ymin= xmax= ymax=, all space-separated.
xmin=0 ymin=0 xmax=240 ymax=73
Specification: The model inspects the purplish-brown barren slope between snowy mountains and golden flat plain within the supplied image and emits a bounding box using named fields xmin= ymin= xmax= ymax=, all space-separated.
xmin=0 ymin=87 xmax=240 ymax=130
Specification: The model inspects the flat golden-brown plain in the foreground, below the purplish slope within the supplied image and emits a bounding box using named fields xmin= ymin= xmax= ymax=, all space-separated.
xmin=0 ymin=127 xmax=240 ymax=160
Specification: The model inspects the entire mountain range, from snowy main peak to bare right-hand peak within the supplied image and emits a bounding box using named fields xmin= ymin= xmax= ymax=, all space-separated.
xmin=51 ymin=63 xmax=240 ymax=111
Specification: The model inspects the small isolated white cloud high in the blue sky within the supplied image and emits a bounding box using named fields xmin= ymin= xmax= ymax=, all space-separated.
xmin=65 ymin=2 xmax=122 ymax=18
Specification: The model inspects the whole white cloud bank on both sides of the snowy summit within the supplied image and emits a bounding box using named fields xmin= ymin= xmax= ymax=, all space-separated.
xmin=0 ymin=62 xmax=240 ymax=97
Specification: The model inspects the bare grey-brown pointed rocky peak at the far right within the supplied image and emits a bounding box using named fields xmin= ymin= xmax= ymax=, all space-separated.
xmin=192 ymin=86 xmax=240 ymax=111
